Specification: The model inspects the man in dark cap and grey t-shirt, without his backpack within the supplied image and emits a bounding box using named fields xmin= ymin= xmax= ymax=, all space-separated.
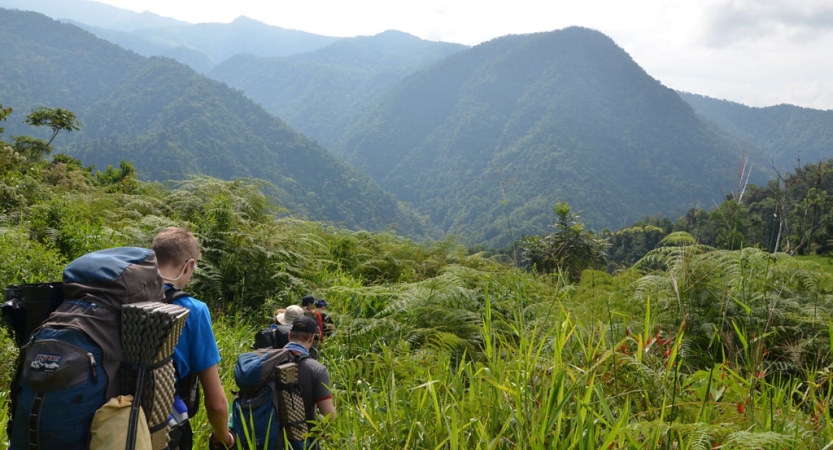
xmin=284 ymin=316 xmax=336 ymax=449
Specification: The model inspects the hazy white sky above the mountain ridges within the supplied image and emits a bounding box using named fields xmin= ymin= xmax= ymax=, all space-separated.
xmin=91 ymin=0 xmax=833 ymax=109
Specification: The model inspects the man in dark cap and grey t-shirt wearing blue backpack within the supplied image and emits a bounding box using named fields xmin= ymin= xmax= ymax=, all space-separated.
xmin=232 ymin=316 xmax=336 ymax=450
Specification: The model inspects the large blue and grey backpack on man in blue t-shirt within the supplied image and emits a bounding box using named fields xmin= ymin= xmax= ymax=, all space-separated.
xmin=9 ymin=247 xmax=165 ymax=450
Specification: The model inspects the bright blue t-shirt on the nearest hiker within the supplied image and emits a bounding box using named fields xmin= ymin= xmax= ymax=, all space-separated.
xmin=173 ymin=290 xmax=220 ymax=378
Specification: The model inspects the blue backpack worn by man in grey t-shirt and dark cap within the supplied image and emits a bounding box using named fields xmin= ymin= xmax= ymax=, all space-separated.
xmin=231 ymin=348 xmax=312 ymax=450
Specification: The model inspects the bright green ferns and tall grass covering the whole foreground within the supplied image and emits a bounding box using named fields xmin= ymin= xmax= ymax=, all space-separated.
xmin=0 ymin=107 xmax=833 ymax=450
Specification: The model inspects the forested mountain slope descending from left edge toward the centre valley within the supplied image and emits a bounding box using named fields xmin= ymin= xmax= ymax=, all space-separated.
xmin=0 ymin=9 xmax=436 ymax=236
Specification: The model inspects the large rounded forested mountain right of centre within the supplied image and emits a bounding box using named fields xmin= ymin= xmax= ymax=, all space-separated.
xmin=334 ymin=28 xmax=752 ymax=245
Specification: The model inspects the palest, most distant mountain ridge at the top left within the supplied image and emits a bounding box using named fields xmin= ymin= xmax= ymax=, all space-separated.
xmin=0 ymin=0 xmax=339 ymax=73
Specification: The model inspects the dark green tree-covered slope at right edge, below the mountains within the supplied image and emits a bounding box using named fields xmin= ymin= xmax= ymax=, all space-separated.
xmin=600 ymin=159 xmax=833 ymax=271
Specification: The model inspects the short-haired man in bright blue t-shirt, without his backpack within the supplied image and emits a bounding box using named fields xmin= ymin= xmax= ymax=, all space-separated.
xmin=151 ymin=227 xmax=234 ymax=450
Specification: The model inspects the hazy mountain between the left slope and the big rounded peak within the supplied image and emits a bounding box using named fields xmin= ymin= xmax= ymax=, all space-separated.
xmin=208 ymin=31 xmax=465 ymax=147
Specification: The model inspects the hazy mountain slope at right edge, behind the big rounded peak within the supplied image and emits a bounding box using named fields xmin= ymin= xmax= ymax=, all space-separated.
xmin=679 ymin=92 xmax=833 ymax=170
